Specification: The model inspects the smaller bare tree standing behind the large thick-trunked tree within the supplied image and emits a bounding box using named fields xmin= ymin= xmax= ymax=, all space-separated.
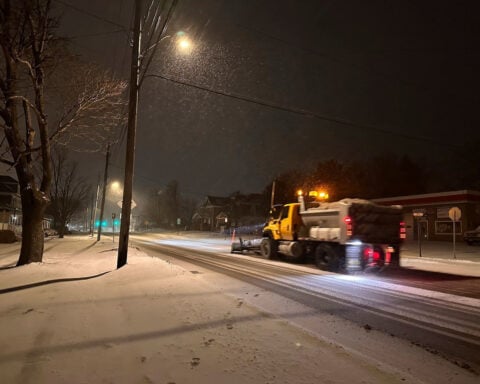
xmin=48 ymin=150 xmax=90 ymax=238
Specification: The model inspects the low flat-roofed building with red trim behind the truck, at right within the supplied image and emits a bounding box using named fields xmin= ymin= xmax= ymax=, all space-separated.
xmin=372 ymin=190 xmax=480 ymax=241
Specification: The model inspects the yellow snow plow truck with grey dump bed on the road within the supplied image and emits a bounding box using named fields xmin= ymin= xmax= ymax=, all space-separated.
xmin=232 ymin=194 xmax=405 ymax=273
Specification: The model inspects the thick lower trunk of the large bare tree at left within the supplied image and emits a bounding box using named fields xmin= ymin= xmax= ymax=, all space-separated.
xmin=17 ymin=188 xmax=48 ymax=266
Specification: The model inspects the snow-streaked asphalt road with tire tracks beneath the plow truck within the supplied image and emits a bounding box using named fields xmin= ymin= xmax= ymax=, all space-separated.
xmin=133 ymin=232 xmax=480 ymax=373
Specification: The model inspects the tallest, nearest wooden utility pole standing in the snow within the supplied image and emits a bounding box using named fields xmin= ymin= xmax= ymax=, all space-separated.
xmin=117 ymin=0 xmax=142 ymax=268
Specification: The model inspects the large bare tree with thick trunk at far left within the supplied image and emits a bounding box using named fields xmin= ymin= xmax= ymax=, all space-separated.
xmin=0 ymin=0 xmax=126 ymax=265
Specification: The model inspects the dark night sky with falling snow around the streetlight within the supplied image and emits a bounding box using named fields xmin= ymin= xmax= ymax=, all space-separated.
xmin=55 ymin=0 xmax=480 ymax=197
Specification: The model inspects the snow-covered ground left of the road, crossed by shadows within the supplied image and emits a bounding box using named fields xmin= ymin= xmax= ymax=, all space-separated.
xmin=0 ymin=236 xmax=478 ymax=384
